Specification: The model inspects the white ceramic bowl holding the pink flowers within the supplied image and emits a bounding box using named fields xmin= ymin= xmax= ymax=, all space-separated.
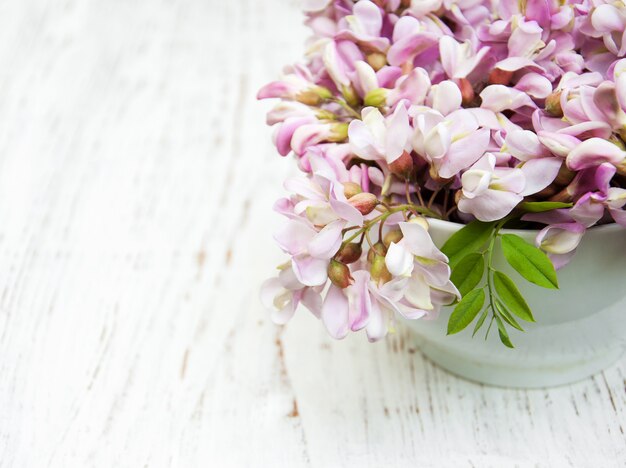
xmin=406 ymin=220 xmax=626 ymax=388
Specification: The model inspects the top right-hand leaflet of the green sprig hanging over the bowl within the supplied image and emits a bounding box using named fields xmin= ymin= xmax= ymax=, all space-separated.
xmin=501 ymin=234 xmax=559 ymax=289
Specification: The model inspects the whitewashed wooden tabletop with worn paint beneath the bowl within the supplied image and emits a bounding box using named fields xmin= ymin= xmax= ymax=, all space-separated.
xmin=0 ymin=0 xmax=626 ymax=468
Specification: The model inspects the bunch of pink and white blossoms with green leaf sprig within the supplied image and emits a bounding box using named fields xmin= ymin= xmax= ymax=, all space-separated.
xmin=258 ymin=0 xmax=626 ymax=347
